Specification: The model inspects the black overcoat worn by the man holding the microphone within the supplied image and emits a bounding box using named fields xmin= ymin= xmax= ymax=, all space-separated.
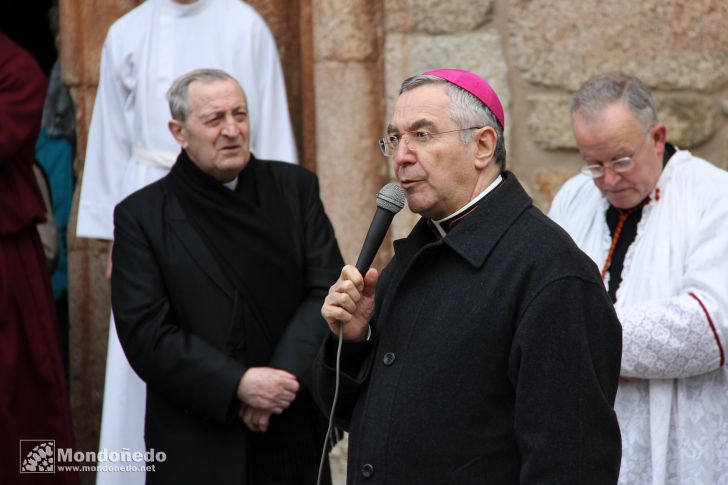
xmin=314 ymin=172 xmax=621 ymax=485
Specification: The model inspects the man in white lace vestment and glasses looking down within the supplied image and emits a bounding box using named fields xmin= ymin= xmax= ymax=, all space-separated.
xmin=549 ymin=73 xmax=728 ymax=485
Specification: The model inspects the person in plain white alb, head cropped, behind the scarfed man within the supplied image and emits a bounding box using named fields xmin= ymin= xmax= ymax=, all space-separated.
xmin=76 ymin=0 xmax=297 ymax=485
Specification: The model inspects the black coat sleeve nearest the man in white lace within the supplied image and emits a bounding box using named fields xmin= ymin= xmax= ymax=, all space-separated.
xmin=509 ymin=277 xmax=622 ymax=484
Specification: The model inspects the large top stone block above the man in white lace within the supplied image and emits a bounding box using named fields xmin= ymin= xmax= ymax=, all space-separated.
xmin=509 ymin=0 xmax=728 ymax=91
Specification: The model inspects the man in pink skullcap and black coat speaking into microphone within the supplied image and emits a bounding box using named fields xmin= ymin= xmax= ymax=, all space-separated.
xmin=314 ymin=69 xmax=621 ymax=485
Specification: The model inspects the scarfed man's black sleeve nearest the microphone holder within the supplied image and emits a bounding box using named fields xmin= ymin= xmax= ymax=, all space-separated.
xmin=271 ymin=173 xmax=344 ymax=389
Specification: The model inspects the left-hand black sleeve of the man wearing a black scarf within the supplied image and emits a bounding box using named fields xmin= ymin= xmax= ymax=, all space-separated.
xmin=111 ymin=199 xmax=246 ymax=421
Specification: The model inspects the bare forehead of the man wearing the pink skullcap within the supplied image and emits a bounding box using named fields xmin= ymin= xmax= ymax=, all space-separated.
xmin=387 ymin=83 xmax=454 ymax=132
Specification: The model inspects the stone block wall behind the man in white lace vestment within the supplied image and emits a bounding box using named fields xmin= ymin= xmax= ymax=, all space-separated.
xmin=506 ymin=0 xmax=728 ymax=208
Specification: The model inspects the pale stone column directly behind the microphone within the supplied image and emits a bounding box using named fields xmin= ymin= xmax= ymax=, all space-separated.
xmin=313 ymin=0 xmax=387 ymax=264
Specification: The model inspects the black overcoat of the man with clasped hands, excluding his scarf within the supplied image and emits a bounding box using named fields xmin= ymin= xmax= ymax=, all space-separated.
xmin=111 ymin=160 xmax=343 ymax=485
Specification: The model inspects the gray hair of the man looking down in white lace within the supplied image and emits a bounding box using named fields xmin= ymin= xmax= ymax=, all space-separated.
xmin=571 ymin=72 xmax=657 ymax=133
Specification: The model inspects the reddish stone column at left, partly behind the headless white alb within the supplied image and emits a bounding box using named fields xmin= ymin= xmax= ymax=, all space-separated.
xmin=60 ymin=0 xmax=139 ymax=483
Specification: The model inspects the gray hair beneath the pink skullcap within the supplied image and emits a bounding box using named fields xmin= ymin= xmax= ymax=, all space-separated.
xmin=399 ymin=74 xmax=506 ymax=172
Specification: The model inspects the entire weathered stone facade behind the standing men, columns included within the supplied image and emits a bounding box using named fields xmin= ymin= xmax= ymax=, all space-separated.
xmin=61 ymin=0 xmax=728 ymax=483
